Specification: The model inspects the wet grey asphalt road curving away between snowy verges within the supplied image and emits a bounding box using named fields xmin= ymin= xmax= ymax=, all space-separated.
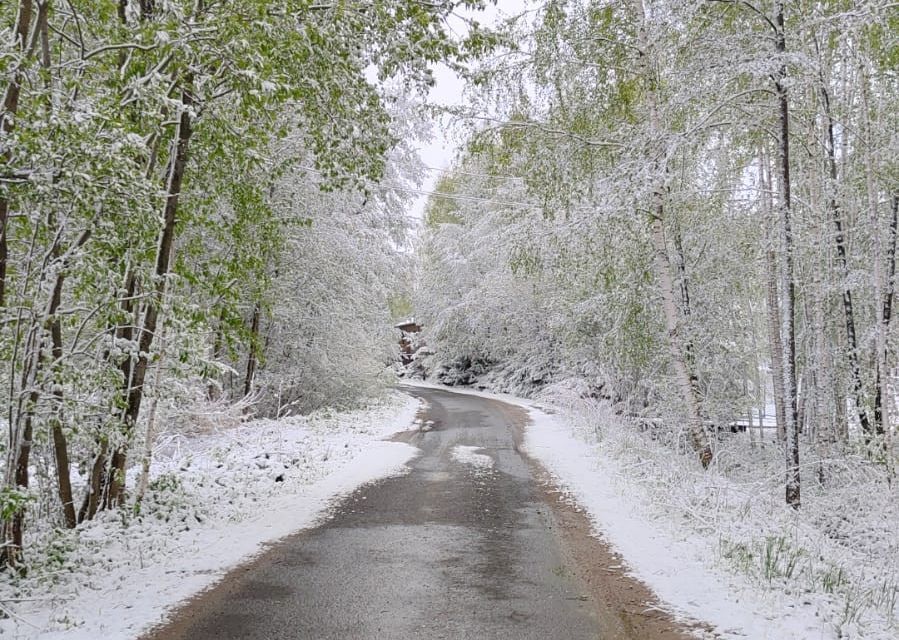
xmin=152 ymin=388 xmax=599 ymax=640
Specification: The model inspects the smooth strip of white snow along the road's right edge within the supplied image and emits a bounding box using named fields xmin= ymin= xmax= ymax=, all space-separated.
xmin=400 ymin=382 xmax=837 ymax=640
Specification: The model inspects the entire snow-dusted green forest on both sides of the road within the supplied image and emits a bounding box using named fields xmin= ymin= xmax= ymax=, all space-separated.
xmin=0 ymin=0 xmax=899 ymax=637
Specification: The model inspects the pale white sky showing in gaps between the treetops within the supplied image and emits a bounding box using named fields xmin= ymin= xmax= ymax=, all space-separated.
xmin=409 ymin=0 xmax=527 ymax=218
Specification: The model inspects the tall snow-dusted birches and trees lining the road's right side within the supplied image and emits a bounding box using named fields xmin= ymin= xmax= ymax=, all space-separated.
xmin=417 ymin=0 xmax=899 ymax=508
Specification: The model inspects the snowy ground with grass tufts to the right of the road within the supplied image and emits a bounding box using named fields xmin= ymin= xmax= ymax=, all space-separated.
xmin=402 ymin=383 xmax=899 ymax=640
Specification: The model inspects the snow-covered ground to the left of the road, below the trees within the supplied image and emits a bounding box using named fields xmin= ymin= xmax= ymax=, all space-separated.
xmin=0 ymin=394 xmax=419 ymax=640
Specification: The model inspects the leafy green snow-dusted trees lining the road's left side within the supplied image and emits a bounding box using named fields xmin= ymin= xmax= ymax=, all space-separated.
xmin=0 ymin=0 xmax=488 ymax=565
